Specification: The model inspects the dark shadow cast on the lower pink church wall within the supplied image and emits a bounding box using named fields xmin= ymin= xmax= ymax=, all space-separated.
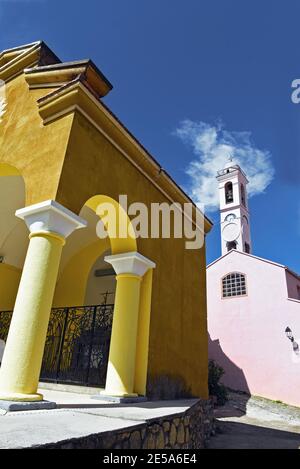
xmin=208 ymin=334 xmax=250 ymax=411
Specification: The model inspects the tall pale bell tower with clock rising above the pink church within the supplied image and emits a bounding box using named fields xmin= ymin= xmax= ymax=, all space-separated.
xmin=217 ymin=159 xmax=252 ymax=256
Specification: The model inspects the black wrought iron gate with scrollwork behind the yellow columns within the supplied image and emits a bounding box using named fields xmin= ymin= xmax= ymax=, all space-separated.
xmin=0 ymin=304 xmax=114 ymax=387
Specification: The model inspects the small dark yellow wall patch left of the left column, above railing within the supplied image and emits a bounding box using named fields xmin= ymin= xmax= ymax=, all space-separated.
xmin=0 ymin=264 xmax=22 ymax=311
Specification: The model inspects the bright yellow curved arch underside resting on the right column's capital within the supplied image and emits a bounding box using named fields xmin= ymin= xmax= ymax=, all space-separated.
xmin=85 ymin=195 xmax=137 ymax=254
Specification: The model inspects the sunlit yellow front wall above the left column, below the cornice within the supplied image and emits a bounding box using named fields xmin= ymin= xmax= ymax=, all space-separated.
xmin=0 ymin=75 xmax=73 ymax=205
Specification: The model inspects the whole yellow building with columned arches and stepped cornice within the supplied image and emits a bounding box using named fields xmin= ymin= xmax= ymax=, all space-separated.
xmin=0 ymin=42 xmax=211 ymax=402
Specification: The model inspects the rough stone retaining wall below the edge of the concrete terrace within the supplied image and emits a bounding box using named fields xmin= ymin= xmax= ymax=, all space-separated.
xmin=39 ymin=400 xmax=215 ymax=449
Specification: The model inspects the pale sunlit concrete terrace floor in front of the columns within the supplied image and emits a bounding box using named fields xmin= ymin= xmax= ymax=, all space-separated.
xmin=0 ymin=389 xmax=197 ymax=449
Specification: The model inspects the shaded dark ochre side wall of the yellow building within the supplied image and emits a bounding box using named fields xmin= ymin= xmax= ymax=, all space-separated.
xmin=57 ymin=113 xmax=207 ymax=398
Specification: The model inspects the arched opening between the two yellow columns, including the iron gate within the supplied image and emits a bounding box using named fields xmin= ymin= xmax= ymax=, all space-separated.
xmin=41 ymin=195 xmax=137 ymax=387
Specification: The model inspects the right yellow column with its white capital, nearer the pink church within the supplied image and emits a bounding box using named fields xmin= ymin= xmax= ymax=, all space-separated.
xmin=99 ymin=252 xmax=155 ymax=398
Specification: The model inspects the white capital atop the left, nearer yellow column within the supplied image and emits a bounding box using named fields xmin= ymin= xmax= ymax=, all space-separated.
xmin=16 ymin=200 xmax=87 ymax=238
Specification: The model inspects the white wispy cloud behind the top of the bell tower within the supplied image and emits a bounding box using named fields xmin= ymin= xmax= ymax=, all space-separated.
xmin=175 ymin=120 xmax=274 ymax=211
